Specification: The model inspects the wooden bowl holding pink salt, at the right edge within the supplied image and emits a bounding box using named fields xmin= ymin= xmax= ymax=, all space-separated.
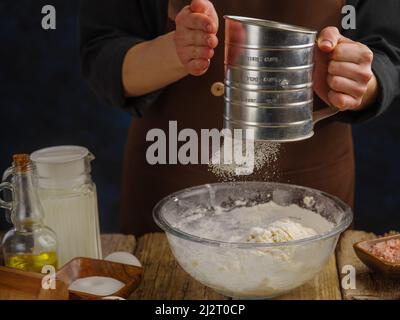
xmin=353 ymin=235 xmax=400 ymax=279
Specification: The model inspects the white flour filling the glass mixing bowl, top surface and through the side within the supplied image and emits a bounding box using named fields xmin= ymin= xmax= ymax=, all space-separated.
xmin=168 ymin=202 xmax=337 ymax=298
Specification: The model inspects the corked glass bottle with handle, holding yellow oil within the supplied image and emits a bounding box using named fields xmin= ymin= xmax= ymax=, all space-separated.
xmin=0 ymin=155 xmax=58 ymax=273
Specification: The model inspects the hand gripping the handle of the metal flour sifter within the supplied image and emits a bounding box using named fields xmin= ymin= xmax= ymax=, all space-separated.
xmin=314 ymin=27 xmax=378 ymax=111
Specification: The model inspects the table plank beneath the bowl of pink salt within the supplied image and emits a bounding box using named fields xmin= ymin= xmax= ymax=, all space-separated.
xmin=337 ymin=231 xmax=400 ymax=300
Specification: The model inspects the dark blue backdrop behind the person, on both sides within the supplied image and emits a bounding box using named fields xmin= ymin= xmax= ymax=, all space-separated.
xmin=0 ymin=0 xmax=400 ymax=232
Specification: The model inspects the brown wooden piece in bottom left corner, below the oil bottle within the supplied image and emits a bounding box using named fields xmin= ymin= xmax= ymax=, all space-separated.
xmin=0 ymin=267 xmax=68 ymax=300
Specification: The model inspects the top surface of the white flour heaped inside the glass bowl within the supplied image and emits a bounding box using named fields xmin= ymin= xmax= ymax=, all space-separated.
xmin=174 ymin=202 xmax=332 ymax=242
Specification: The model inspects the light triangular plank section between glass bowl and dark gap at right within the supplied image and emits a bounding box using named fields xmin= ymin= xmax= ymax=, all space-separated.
xmin=277 ymin=255 xmax=342 ymax=300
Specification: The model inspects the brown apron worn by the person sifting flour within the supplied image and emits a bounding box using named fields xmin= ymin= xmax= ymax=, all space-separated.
xmin=121 ymin=0 xmax=355 ymax=236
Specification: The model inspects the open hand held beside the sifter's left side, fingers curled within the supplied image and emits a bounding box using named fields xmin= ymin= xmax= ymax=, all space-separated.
xmin=174 ymin=0 xmax=219 ymax=76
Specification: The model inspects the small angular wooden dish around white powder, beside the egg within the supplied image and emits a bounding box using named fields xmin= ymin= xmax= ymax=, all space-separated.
xmin=57 ymin=258 xmax=143 ymax=300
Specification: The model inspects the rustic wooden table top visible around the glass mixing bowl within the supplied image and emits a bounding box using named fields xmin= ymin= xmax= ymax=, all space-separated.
xmin=102 ymin=231 xmax=400 ymax=300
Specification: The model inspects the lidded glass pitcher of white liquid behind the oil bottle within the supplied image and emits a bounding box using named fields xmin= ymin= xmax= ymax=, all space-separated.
xmin=31 ymin=146 xmax=102 ymax=266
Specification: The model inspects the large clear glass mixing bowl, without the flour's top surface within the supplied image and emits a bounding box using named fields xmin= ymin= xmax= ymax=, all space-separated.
xmin=153 ymin=182 xmax=353 ymax=299
